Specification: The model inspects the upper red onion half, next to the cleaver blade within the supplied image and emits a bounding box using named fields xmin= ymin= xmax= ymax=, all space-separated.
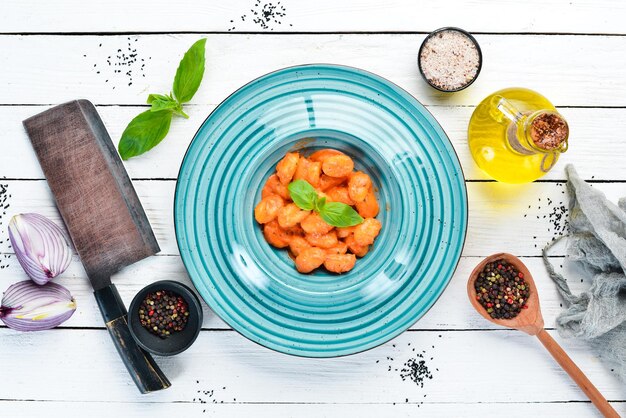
xmin=9 ymin=213 xmax=72 ymax=285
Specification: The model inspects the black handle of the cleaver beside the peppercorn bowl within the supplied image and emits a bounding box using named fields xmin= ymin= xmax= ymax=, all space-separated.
xmin=94 ymin=284 xmax=170 ymax=393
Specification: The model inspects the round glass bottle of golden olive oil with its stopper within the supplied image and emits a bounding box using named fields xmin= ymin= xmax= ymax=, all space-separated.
xmin=468 ymin=88 xmax=569 ymax=183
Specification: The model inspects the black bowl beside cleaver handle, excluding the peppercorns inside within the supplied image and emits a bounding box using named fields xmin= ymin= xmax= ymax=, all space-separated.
xmin=128 ymin=280 xmax=202 ymax=356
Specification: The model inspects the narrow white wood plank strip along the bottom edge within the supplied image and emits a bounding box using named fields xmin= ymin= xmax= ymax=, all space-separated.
xmin=0 ymin=401 xmax=626 ymax=418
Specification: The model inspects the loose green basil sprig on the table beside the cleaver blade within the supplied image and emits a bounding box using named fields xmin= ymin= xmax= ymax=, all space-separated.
xmin=118 ymin=39 xmax=206 ymax=160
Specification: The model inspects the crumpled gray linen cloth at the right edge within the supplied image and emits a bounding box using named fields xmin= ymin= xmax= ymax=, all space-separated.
xmin=543 ymin=165 xmax=626 ymax=382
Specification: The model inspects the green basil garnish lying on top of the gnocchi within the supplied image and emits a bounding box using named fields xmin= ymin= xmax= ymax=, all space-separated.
xmin=287 ymin=180 xmax=363 ymax=228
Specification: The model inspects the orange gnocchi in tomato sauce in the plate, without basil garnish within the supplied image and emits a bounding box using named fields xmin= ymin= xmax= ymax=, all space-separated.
xmin=254 ymin=149 xmax=382 ymax=273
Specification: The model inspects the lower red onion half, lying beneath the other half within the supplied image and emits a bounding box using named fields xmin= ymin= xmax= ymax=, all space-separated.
xmin=0 ymin=280 xmax=76 ymax=331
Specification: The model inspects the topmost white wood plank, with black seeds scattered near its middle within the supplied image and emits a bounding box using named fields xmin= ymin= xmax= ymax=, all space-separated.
xmin=0 ymin=0 xmax=626 ymax=33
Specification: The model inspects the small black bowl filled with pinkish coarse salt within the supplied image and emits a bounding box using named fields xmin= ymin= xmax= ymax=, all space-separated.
xmin=417 ymin=27 xmax=483 ymax=93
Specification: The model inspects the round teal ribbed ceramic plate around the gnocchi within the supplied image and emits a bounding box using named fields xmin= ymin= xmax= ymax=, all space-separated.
xmin=174 ymin=65 xmax=467 ymax=357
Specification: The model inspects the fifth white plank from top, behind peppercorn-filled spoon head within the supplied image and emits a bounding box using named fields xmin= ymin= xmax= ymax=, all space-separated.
xmin=0 ymin=256 xmax=589 ymax=330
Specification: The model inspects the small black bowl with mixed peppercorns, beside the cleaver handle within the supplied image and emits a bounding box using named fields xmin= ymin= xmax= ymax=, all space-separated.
xmin=128 ymin=280 xmax=202 ymax=356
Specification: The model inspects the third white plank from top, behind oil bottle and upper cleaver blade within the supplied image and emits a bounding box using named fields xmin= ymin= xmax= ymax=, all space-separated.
xmin=0 ymin=105 xmax=626 ymax=180
